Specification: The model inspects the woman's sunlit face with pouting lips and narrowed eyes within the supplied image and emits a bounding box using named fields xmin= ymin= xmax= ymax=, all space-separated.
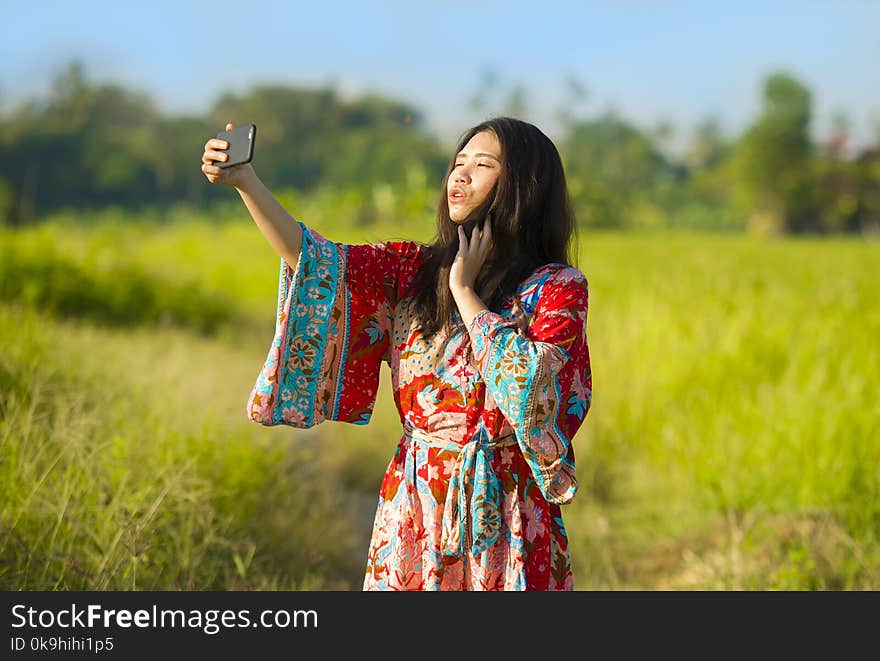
xmin=446 ymin=131 xmax=501 ymax=223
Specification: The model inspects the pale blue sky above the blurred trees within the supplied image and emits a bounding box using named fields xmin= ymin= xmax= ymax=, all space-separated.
xmin=0 ymin=0 xmax=880 ymax=149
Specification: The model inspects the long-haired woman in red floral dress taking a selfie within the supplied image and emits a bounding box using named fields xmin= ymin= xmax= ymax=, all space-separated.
xmin=202 ymin=117 xmax=592 ymax=590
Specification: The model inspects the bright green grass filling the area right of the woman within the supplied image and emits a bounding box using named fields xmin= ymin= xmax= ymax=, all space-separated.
xmin=569 ymin=229 xmax=880 ymax=588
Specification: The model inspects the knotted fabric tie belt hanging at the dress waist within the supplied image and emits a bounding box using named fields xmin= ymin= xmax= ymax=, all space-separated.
xmin=403 ymin=422 xmax=516 ymax=558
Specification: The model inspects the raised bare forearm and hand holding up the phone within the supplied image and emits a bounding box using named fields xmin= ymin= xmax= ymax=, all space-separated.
xmin=202 ymin=124 xmax=302 ymax=268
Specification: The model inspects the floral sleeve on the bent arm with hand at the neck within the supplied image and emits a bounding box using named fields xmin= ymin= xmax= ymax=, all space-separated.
xmin=468 ymin=266 xmax=592 ymax=504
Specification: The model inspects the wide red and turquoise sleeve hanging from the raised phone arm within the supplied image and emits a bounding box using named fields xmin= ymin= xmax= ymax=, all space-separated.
xmin=247 ymin=221 xmax=419 ymax=428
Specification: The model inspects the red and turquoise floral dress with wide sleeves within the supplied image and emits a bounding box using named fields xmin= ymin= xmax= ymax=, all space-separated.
xmin=247 ymin=222 xmax=592 ymax=590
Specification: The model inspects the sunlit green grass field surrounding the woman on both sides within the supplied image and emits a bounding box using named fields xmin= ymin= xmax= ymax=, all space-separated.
xmin=0 ymin=210 xmax=880 ymax=590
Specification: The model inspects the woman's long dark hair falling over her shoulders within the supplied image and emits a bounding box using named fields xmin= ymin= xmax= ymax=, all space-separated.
xmin=413 ymin=117 xmax=577 ymax=339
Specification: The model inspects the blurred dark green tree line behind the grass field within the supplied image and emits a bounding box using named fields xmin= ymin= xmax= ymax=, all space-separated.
xmin=0 ymin=61 xmax=880 ymax=233
